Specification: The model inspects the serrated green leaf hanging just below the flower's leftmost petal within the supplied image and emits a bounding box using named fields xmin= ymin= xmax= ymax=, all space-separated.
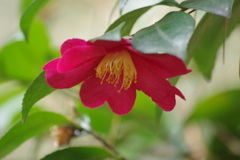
xmin=22 ymin=71 xmax=56 ymax=122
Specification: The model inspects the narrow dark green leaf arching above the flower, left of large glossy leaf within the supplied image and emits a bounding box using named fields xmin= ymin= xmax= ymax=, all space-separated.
xmin=106 ymin=0 xmax=178 ymax=37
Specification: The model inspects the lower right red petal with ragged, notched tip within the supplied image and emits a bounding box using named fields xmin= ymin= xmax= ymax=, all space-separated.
xmin=133 ymin=56 xmax=185 ymax=111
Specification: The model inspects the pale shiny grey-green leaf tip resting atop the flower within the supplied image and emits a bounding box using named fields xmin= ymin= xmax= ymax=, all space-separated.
xmin=91 ymin=22 xmax=124 ymax=41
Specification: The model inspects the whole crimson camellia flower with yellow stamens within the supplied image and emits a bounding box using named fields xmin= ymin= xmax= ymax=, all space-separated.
xmin=43 ymin=39 xmax=190 ymax=115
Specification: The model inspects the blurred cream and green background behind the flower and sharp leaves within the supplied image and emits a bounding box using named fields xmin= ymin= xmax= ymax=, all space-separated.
xmin=0 ymin=0 xmax=240 ymax=160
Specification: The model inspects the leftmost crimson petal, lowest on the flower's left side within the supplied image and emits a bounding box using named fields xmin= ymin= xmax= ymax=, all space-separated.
xmin=45 ymin=59 xmax=100 ymax=89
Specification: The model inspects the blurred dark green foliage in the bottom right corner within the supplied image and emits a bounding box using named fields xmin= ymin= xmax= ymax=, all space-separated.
xmin=187 ymin=89 xmax=240 ymax=160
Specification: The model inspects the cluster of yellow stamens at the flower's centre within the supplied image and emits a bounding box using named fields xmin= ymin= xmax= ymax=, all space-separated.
xmin=96 ymin=50 xmax=137 ymax=92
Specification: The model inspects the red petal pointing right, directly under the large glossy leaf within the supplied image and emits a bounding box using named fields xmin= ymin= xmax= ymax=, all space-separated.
xmin=126 ymin=46 xmax=191 ymax=78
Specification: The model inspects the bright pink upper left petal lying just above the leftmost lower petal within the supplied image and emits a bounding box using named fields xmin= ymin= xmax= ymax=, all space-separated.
xmin=57 ymin=46 xmax=107 ymax=73
